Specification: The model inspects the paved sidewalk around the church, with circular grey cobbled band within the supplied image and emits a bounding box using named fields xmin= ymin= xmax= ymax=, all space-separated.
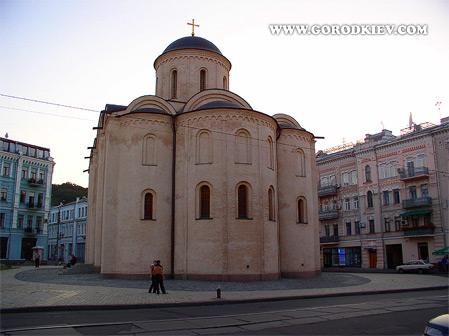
xmin=0 ymin=266 xmax=448 ymax=313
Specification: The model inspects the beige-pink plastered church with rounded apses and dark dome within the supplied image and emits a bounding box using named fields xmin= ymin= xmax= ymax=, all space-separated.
xmin=86 ymin=34 xmax=320 ymax=281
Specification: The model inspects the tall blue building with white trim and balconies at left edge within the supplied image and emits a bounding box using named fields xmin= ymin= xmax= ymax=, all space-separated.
xmin=0 ymin=138 xmax=55 ymax=263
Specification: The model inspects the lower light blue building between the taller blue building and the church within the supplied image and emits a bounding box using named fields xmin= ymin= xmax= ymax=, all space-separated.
xmin=47 ymin=197 xmax=87 ymax=263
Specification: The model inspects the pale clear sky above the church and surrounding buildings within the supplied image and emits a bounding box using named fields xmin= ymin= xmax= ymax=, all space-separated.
xmin=0 ymin=0 xmax=449 ymax=187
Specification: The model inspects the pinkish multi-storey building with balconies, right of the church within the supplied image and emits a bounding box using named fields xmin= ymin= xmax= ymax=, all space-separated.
xmin=317 ymin=118 xmax=449 ymax=269
